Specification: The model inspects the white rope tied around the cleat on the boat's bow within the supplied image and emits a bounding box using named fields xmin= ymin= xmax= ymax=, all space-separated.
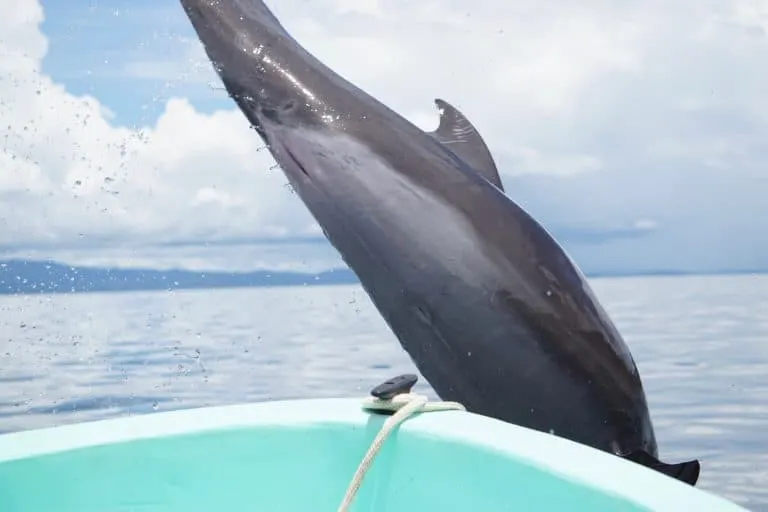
xmin=338 ymin=393 xmax=466 ymax=512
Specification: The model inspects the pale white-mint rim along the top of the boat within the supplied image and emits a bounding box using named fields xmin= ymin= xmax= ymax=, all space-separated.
xmin=0 ymin=398 xmax=746 ymax=511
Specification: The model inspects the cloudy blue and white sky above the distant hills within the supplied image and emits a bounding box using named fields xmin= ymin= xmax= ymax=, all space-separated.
xmin=0 ymin=0 xmax=768 ymax=273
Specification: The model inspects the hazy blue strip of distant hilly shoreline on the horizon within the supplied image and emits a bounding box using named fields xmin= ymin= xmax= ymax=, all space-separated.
xmin=0 ymin=259 xmax=768 ymax=295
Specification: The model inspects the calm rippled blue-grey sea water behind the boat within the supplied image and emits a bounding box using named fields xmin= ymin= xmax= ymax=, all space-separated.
xmin=0 ymin=276 xmax=768 ymax=510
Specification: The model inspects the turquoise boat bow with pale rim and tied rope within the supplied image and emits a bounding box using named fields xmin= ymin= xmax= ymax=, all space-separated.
xmin=0 ymin=374 xmax=745 ymax=512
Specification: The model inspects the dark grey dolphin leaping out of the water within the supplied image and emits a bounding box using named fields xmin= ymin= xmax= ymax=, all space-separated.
xmin=181 ymin=0 xmax=699 ymax=485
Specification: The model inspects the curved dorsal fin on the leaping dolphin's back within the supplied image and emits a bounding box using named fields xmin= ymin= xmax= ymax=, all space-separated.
xmin=429 ymin=98 xmax=504 ymax=191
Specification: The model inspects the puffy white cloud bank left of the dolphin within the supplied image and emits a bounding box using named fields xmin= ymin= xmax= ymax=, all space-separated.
xmin=0 ymin=2 xmax=317 ymax=250
